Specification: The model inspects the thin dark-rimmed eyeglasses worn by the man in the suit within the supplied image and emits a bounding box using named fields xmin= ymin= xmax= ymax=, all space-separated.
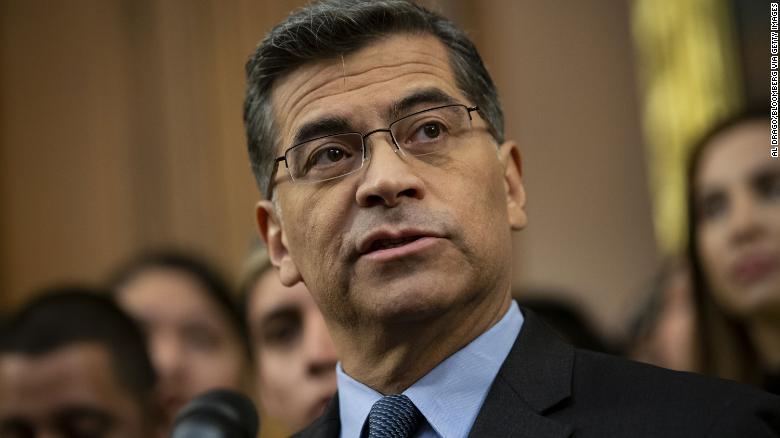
xmin=267 ymin=104 xmax=478 ymax=199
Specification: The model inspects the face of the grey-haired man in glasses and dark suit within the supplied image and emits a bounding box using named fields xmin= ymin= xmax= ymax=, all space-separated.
xmin=258 ymin=34 xmax=526 ymax=326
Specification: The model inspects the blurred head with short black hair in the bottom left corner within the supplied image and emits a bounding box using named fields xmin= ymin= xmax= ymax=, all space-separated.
xmin=0 ymin=287 xmax=163 ymax=438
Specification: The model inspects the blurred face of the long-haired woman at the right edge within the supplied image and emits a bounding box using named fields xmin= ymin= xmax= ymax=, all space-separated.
xmin=695 ymin=121 xmax=780 ymax=317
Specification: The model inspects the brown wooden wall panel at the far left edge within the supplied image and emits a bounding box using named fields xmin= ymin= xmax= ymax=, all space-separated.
xmin=0 ymin=1 xmax=132 ymax=308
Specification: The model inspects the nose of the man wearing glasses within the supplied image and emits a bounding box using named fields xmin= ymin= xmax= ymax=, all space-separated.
xmin=355 ymin=133 xmax=425 ymax=207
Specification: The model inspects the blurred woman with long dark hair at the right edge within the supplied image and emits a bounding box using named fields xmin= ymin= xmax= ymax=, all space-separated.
xmin=688 ymin=108 xmax=780 ymax=393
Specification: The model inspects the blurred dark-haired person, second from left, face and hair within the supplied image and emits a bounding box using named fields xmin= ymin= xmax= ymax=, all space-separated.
xmin=111 ymin=251 xmax=249 ymax=430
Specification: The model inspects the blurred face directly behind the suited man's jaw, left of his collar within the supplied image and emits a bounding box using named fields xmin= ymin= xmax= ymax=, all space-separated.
xmin=247 ymin=269 xmax=337 ymax=430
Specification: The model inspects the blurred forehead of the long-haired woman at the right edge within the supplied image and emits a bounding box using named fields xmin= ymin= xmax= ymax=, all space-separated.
xmin=697 ymin=120 xmax=780 ymax=186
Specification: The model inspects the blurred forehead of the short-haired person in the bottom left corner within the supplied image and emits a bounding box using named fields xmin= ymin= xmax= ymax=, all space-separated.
xmin=0 ymin=343 xmax=131 ymax=415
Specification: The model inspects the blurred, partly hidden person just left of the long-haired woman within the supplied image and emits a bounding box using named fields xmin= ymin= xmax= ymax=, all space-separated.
xmin=625 ymin=259 xmax=698 ymax=371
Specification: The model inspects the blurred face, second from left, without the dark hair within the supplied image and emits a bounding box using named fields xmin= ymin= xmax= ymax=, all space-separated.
xmin=113 ymin=268 xmax=245 ymax=426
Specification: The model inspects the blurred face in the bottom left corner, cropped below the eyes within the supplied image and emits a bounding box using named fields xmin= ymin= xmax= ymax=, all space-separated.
xmin=0 ymin=343 xmax=153 ymax=438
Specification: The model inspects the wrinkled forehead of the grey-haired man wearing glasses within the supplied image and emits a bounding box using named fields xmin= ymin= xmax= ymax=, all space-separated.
xmin=271 ymin=34 xmax=465 ymax=151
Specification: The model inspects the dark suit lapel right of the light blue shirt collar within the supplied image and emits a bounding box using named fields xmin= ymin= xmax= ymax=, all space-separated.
xmin=469 ymin=310 xmax=574 ymax=438
